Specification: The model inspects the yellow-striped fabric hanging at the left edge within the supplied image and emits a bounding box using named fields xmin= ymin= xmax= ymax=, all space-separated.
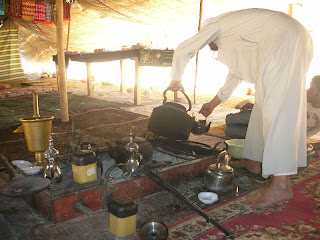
xmin=0 ymin=29 xmax=25 ymax=82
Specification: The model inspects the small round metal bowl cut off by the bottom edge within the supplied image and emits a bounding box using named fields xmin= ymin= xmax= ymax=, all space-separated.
xmin=139 ymin=221 xmax=169 ymax=240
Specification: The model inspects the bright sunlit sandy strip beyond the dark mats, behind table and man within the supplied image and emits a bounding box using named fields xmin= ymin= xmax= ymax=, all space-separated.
xmin=1 ymin=78 xmax=254 ymax=126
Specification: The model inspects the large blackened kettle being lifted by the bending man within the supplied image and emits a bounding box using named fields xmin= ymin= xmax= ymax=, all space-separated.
xmin=148 ymin=88 xmax=194 ymax=140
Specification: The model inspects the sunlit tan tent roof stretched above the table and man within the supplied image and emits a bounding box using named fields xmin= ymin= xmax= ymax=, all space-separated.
xmin=0 ymin=0 xmax=316 ymax=68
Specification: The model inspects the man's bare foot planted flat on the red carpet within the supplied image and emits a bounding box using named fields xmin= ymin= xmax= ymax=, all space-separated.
xmin=245 ymin=176 xmax=293 ymax=208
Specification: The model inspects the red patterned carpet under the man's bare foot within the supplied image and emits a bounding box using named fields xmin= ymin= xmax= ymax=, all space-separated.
xmin=168 ymin=158 xmax=320 ymax=240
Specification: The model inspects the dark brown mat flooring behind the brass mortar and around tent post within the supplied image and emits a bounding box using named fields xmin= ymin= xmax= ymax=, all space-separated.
xmin=0 ymin=92 xmax=149 ymax=159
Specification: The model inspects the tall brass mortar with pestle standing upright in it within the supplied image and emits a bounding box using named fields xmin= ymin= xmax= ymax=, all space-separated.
xmin=20 ymin=93 xmax=54 ymax=167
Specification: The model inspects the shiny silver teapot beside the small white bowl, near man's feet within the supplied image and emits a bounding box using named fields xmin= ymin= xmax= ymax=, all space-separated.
xmin=204 ymin=146 xmax=234 ymax=192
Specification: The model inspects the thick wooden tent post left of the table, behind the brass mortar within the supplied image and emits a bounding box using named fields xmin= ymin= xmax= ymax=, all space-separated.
xmin=56 ymin=0 xmax=69 ymax=122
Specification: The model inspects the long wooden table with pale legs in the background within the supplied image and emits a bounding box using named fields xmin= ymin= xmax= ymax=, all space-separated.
xmin=53 ymin=48 xmax=174 ymax=105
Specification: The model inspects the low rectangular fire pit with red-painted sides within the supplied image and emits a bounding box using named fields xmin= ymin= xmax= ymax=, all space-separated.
xmin=20 ymin=135 xmax=220 ymax=222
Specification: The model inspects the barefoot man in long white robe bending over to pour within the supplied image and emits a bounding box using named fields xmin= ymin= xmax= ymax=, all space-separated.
xmin=169 ymin=9 xmax=313 ymax=208
